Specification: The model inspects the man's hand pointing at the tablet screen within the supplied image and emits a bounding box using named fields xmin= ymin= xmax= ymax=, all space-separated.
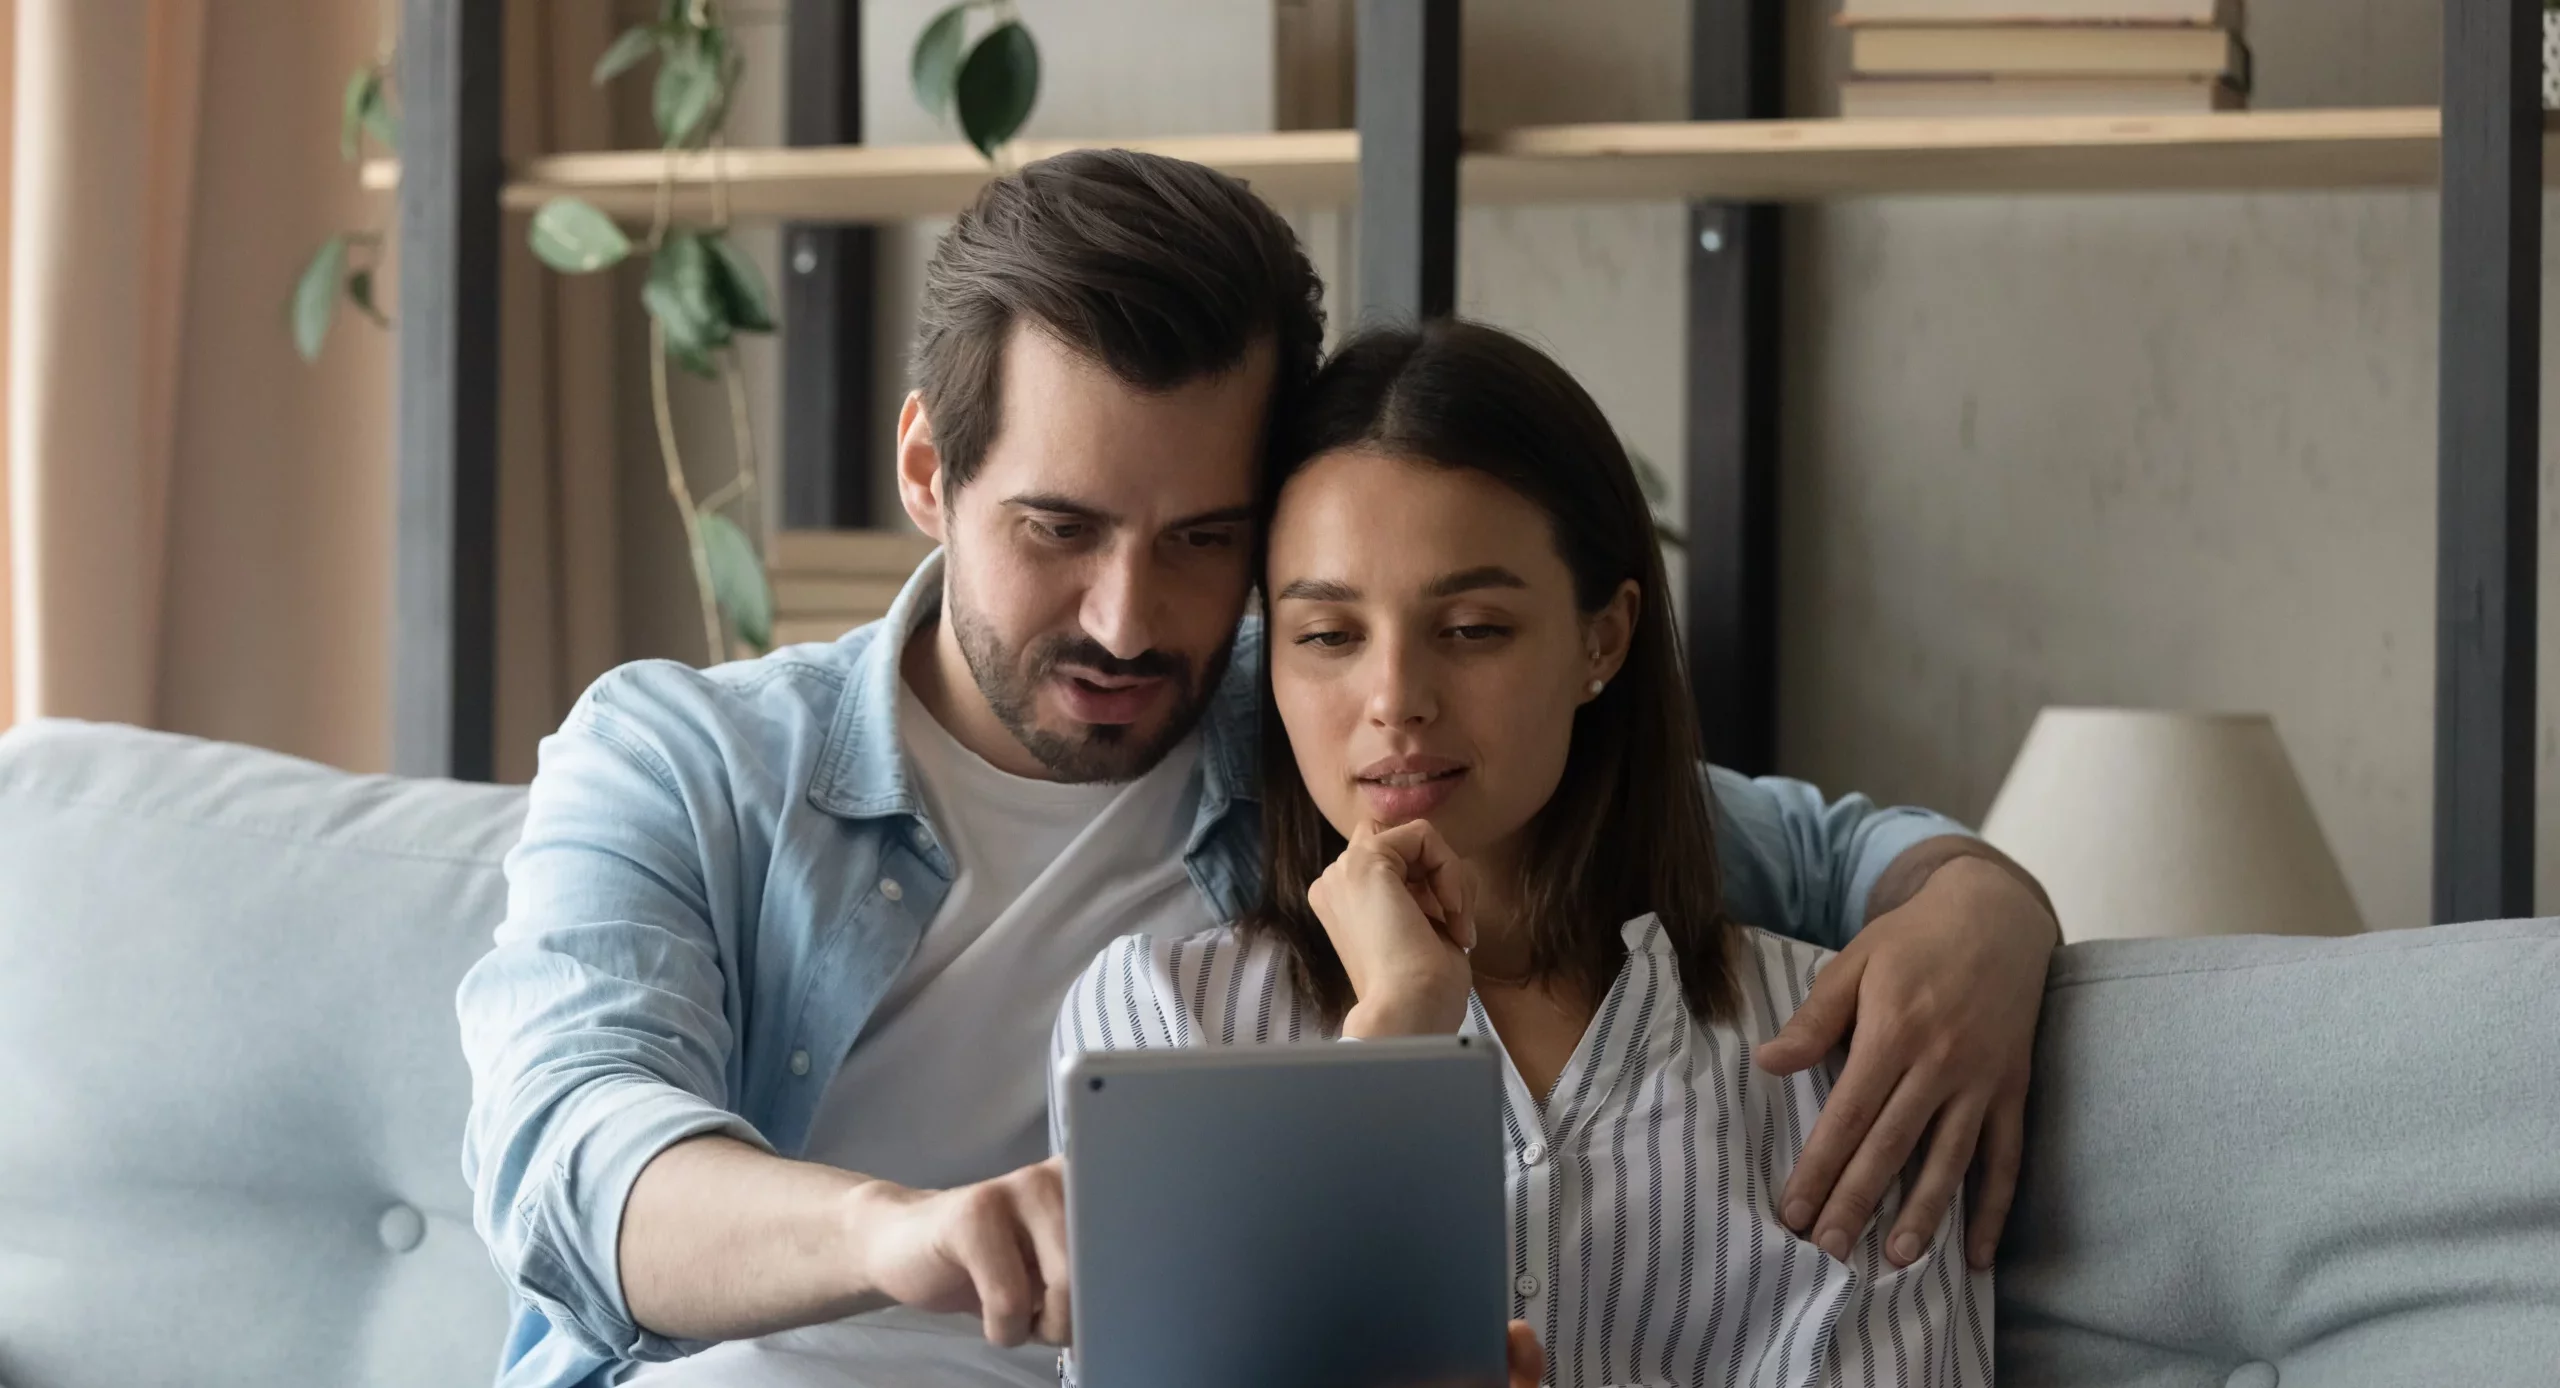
xmin=850 ymin=1158 xmax=1073 ymax=1347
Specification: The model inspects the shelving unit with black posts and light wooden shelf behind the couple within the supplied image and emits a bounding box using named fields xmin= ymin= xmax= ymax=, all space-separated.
xmin=399 ymin=0 xmax=2560 ymax=919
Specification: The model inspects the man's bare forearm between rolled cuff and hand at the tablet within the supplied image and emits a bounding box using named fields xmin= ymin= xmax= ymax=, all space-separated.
xmin=617 ymin=1137 xmax=888 ymax=1339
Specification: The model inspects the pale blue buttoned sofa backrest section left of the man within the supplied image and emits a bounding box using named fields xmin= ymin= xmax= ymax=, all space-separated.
xmin=0 ymin=722 xmax=522 ymax=1388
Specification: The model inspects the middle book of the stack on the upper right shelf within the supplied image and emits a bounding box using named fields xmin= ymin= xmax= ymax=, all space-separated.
xmin=1848 ymin=26 xmax=2248 ymax=90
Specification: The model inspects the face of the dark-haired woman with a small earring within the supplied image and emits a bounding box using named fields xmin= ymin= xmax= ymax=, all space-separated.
xmin=1265 ymin=448 xmax=1636 ymax=858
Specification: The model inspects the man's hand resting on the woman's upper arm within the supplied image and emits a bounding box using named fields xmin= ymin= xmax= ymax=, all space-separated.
xmin=1759 ymin=840 xmax=2061 ymax=1268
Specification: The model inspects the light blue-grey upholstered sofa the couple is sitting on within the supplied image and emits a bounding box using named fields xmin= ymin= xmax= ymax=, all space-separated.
xmin=0 ymin=725 xmax=2560 ymax=1388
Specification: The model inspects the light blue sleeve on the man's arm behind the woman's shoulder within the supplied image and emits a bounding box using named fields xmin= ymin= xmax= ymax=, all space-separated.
xmin=1708 ymin=766 xmax=1974 ymax=950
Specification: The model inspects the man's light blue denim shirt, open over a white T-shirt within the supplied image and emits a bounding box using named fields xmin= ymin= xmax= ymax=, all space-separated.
xmin=456 ymin=556 xmax=1964 ymax=1388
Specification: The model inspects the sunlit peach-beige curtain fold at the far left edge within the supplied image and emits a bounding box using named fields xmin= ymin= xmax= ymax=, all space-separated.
xmin=5 ymin=0 xmax=205 ymax=722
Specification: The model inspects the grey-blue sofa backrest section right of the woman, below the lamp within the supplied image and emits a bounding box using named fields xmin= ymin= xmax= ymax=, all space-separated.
xmin=1999 ymin=919 xmax=2560 ymax=1388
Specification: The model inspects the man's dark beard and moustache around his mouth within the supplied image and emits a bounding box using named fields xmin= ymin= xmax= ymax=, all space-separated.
xmin=942 ymin=571 xmax=1236 ymax=781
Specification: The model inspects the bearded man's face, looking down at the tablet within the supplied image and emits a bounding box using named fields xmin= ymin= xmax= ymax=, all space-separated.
xmin=909 ymin=328 xmax=1272 ymax=781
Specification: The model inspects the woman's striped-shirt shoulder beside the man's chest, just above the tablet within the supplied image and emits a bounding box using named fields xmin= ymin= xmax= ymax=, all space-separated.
xmin=1057 ymin=924 xmax=1316 ymax=1050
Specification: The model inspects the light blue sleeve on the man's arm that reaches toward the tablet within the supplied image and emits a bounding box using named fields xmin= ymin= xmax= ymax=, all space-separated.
xmin=456 ymin=697 xmax=771 ymax=1360
